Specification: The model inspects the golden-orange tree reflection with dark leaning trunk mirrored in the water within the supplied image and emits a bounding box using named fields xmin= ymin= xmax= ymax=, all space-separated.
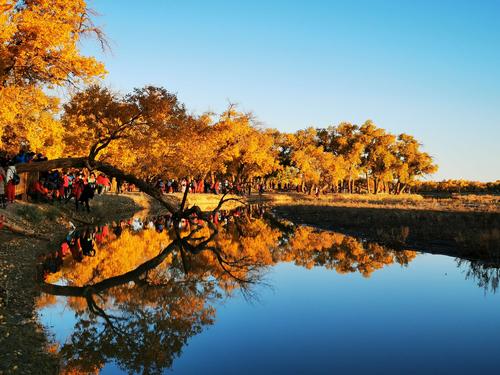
xmin=39 ymin=210 xmax=416 ymax=373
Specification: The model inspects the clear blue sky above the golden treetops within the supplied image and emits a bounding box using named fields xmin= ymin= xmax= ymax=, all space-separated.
xmin=84 ymin=0 xmax=500 ymax=181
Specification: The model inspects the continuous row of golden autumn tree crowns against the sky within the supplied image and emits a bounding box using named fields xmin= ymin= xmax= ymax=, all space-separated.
xmin=4 ymin=0 xmax=437 ymax=193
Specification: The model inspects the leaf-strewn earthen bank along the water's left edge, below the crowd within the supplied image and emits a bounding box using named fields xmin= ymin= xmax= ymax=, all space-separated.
xmin=0 ymin=194 xmax=161 ymax=374
